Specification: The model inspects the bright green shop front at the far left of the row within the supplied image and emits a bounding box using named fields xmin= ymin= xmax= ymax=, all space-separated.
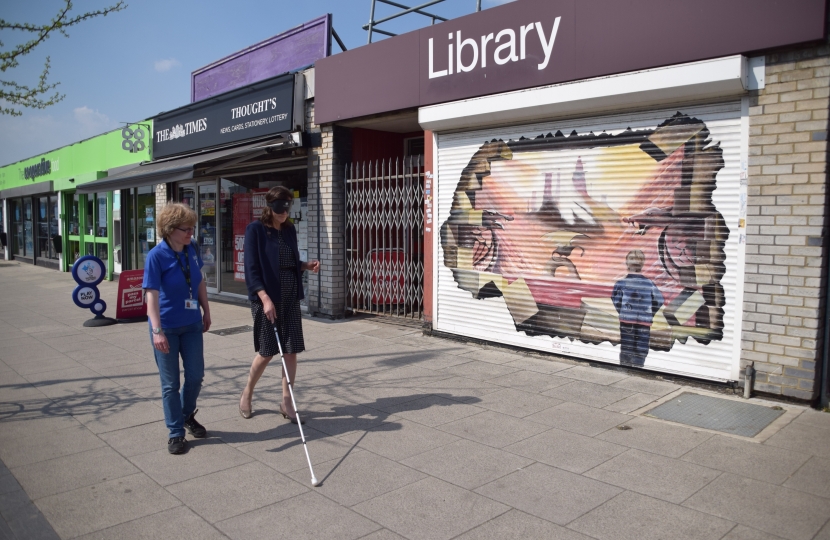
xmin=0 ymin=122 xmax=155 ymax=279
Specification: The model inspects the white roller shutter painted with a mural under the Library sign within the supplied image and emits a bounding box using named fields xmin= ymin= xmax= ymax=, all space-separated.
xmin=433 ymin=102 xmax=746 ymax=380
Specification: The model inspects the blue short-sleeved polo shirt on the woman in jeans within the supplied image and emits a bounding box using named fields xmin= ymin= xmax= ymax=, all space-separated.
xmin=141 ymin=242 xmax=204 ymax=328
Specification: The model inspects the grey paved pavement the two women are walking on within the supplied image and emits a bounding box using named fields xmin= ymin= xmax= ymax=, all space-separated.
xmin=0 ymin=262 xmax=830 ymax=540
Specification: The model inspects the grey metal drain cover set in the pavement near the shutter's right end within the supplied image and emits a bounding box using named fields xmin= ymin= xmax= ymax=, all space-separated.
xmin=645 ymin=392 xmax=784 ymax=437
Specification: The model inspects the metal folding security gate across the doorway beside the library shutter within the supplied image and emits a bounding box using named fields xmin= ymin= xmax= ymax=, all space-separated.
xmin=346 ymin=156 xmax=424 ymax=319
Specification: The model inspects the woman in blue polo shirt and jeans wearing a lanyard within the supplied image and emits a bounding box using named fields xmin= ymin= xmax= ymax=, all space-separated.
xmin=142 ymin=203 xmax=210 ymax=454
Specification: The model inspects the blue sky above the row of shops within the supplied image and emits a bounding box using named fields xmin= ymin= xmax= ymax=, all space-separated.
xmin=0 ymin=0 xmax=512 ymax=166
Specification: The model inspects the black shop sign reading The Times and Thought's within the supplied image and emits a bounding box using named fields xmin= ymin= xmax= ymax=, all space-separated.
xmin=153 ymin=74 xmax=294 ymax=159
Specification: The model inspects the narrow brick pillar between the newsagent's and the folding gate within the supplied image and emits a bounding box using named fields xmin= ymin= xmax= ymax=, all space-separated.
xmin=306 ymin=100 xmax=351 ymax=318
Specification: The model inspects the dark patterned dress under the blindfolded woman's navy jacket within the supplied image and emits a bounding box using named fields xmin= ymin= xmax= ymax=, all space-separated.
xmin=251 ymin=229 xmax=305 ymax=357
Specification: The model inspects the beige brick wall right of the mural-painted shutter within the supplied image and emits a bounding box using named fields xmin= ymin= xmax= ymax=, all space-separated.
xmin=741 ymin=45 xmax=830 ymax=400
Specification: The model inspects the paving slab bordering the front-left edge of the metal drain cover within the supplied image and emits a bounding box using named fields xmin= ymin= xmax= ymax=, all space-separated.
xmin=597 ymin=417 xmax=714 ymax=458
